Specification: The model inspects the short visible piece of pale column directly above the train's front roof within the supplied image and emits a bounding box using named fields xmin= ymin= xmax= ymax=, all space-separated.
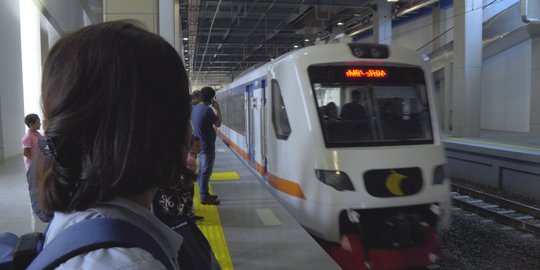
xmin=373 ymin=1 xmax=392 ymax=44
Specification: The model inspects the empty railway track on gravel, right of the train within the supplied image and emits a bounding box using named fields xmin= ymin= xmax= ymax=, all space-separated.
xmin=452 ymin=184 xmax=540 ymax=237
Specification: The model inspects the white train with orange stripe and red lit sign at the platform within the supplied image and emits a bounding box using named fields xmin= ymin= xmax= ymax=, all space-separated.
xmin=216 ymin=43 xmax=450 ymax=269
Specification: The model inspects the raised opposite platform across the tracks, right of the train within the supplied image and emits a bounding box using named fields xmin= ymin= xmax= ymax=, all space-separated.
xmin=442 ymin=130 xmax=540 ymax=201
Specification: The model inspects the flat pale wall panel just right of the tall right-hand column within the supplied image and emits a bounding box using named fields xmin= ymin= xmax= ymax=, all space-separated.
xmin=480 ymin=39 xmax=531 ymax=132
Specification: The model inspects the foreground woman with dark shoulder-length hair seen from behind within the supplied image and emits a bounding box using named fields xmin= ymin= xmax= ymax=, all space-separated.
xmin=35 ymin=22 xmax=193 ymax=269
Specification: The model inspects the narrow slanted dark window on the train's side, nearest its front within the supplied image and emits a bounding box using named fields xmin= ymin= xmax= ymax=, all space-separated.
xmin=272 ymin=79 xmax=291 ymax=140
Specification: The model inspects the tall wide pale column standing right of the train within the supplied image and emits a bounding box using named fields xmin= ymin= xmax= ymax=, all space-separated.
xmin=452 ymin=0 xmax=482 ymax=137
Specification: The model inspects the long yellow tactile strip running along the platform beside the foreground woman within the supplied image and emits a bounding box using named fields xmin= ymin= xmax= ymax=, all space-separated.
xmin=193 ymin=182 xmax=238 ymax=270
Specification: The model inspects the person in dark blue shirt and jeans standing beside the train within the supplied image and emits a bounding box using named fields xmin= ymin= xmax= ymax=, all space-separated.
xmin=191 ymin=86 xmax=221 ymax=205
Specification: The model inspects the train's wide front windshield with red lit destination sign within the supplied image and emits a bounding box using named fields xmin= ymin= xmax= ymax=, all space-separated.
xmin=308 ymin=65 xmax=433 ymax=147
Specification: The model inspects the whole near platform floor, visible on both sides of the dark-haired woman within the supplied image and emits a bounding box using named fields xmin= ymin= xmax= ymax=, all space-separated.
xmin=0 ymin=139 xmax=340 ymax=270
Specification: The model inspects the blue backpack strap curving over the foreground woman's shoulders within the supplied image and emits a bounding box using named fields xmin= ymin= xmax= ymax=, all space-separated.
xmin=27 ymin=218 xmax=174 ymax=270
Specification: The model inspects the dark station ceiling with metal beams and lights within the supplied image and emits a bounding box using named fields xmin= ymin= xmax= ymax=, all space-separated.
xmin=180 ymin=0 xmax=438 ymax=86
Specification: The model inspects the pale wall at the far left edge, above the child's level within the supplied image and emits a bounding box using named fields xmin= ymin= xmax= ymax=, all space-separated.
xmin=0 ymin=0 xmax=25 ymax=162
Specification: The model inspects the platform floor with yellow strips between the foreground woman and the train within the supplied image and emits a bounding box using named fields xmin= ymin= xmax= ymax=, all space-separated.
xmin=194 ymin=138 xmax=341 ymax=270
